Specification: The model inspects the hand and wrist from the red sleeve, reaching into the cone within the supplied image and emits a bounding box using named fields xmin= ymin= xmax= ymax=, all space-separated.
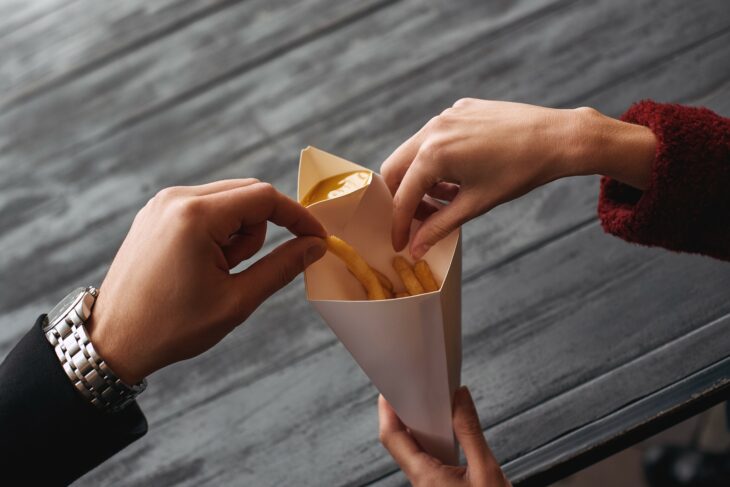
xmin=381 ymin=99 xmax=656 ymax=259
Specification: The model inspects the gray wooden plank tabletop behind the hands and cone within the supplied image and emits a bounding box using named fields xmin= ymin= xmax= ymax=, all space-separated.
xmin=0 ymin=0 xmax=730 ymax=486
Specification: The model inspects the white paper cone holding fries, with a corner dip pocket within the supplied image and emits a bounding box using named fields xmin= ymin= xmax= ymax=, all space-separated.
xmin=297 ymin=147 xmax=461 ymax=465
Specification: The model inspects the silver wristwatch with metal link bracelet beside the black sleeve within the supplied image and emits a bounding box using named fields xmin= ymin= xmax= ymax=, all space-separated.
xmin=43 ymin=287 xmax=147 ymax=412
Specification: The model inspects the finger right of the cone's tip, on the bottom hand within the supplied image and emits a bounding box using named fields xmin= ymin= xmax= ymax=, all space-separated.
xmin=453 ymin=386 xmax=503 ymax=485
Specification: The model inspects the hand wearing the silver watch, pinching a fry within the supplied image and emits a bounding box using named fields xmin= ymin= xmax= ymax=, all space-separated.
xmin=88 ymin=179 xmax=326 ymax=384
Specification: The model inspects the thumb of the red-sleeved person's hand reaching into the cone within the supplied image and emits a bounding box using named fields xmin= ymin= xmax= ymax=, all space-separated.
xmin=410 ymin=193 xmax=478 ymax=260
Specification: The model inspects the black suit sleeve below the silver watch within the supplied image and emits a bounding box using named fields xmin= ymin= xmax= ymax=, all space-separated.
xmin=0 ymin=316 xmax=147 ymax=485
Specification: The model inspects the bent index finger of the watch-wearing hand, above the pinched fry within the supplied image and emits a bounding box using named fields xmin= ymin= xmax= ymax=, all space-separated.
xmin=204 ymin=183 xmax=326 ymax=244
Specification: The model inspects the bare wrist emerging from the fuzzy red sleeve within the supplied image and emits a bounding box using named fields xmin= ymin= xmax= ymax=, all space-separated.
xmin=567 ymin=107 xmax=656 ymax=190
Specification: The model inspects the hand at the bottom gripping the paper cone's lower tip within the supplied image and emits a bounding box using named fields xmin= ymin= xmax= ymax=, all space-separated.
xmin=378 ymin=386 xmax=511 ymax=487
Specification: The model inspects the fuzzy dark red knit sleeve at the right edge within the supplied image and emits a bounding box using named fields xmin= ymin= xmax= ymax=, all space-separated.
xmin=598 ymin=101 xmax=730 ymax=260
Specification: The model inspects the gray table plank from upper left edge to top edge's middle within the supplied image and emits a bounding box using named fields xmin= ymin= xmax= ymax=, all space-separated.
xmin=0 ymin=0 xmax=389 ymax=175
